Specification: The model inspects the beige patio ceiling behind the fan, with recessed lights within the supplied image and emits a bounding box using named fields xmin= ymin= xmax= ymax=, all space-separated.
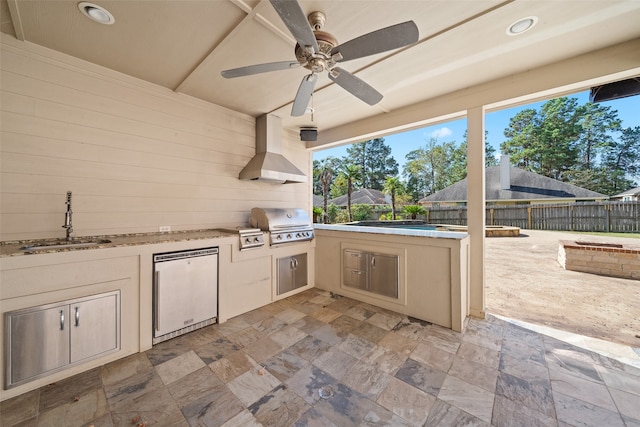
xmin=0 ymin=0 xmax=640 ymax=140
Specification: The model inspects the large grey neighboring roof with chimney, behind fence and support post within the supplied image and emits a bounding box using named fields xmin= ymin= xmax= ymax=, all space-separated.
xmin=419 ymin=166 xmax=608 ymax=203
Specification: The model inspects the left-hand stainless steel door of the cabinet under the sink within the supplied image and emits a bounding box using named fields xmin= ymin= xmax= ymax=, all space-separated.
xmin=5 ymin=304 xmax=70 ymax=386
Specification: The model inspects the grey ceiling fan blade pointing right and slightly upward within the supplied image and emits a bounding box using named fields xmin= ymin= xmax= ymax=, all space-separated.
xmin=331 ymin=21 xmax=419 ymax=62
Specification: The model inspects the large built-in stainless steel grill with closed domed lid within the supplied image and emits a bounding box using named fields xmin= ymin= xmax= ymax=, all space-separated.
xmin=249 ymin=208 xmax=313 ymax=246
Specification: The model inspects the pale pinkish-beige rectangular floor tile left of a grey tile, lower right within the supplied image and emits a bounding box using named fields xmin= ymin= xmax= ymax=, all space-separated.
xmin=438 ymin=375 xmax=495 ymax=423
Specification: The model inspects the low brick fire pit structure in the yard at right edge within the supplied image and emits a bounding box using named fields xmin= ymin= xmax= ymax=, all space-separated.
xmin=558 ymin=240 xmax=640 ymax=280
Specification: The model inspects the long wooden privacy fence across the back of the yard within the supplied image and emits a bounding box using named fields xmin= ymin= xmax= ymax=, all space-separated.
xmin=426 ymin=202 xmax=640 ymax=233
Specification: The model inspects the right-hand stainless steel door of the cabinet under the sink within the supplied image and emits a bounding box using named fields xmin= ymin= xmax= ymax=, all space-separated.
xmin=69 ymin=294 xmax=119 ymax=363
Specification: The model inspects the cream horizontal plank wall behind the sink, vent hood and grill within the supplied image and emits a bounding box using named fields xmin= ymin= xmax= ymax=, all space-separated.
xmin=0 ymin=34 xmax=311 ymax=240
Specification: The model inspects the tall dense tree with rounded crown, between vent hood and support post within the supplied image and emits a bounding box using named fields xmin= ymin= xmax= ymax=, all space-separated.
xmin=345 ymin=138 xmax=398 ymax=190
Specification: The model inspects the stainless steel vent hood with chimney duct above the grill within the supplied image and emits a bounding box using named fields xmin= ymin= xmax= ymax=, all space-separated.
xmin=239 ymin=114 xmax=307 ymax=184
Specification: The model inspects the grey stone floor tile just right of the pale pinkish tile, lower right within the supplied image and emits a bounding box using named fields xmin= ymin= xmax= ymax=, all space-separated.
xmin=496 ymin=372 xmax=555 ymax=417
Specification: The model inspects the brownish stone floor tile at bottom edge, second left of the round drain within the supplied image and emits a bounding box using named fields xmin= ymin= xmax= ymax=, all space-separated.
xmin=180 ymin=384 xmax=245 ymax=427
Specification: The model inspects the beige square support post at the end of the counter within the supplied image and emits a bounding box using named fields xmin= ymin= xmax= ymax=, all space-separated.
xmin=467 ymin=106 xmax=486 ymax=318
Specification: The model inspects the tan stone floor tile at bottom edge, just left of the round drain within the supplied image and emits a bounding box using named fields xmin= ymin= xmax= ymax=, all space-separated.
xmin=248 ymin=384 xmax=309 ymax=427
